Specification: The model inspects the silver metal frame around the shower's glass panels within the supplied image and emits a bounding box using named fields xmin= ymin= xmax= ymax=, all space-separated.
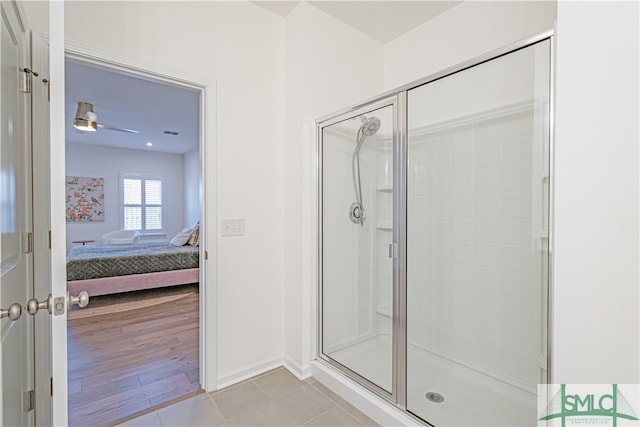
xmin=312 ymin=30 xmax=556 ymax=424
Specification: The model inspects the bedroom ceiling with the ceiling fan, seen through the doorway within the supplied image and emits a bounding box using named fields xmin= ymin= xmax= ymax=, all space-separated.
xmin=65 ymin=60 xmax=200 ymax=154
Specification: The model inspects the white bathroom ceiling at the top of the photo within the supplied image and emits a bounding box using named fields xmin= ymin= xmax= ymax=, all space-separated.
xmin=253 ymin=0 xmax=461 ymax=43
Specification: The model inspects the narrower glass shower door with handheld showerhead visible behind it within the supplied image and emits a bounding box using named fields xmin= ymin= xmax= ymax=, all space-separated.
xmin=319 ymin=97 xmax=395 ymax=394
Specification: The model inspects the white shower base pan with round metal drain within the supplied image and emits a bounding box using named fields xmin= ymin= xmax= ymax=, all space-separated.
xmin=329 ymin=335 xmax=537 ymax=427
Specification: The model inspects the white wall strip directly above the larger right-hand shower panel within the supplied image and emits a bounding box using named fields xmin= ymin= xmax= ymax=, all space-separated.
xmin=384 ymin=1 xmax=555 ymax=89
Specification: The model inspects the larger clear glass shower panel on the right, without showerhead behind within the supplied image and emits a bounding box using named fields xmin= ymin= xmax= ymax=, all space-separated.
xmin=406 ymin=40 xmax=551 ymax=426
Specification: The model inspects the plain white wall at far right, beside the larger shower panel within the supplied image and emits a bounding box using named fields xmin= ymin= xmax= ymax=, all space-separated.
xmin=553 ymin=1 xmax=640 ymax=383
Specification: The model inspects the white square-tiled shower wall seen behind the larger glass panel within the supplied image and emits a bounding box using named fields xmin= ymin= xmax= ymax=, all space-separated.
xmin=408 ymin=110 xmax=541 ymax=390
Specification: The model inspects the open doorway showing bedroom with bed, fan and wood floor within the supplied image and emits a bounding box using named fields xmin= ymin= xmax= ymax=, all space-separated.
xmin=65 ymin=57 xmax=204 ymax=426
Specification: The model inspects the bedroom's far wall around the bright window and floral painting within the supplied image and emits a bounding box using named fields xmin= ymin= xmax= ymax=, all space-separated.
xmin=65 ymin=143 xmax=184 ymax=250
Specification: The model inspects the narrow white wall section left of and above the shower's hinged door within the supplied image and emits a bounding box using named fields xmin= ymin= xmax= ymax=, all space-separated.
xmin=281 ymin=3 xmax=383 ymax=375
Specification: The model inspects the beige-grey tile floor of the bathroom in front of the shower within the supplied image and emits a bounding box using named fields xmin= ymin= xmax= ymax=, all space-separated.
xmin=120 ymin=368 xmax=378 ymax=427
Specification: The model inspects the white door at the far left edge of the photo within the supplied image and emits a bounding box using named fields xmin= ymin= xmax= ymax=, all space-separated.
xmin=0 ymin=1 xmax=33 ymax=426
